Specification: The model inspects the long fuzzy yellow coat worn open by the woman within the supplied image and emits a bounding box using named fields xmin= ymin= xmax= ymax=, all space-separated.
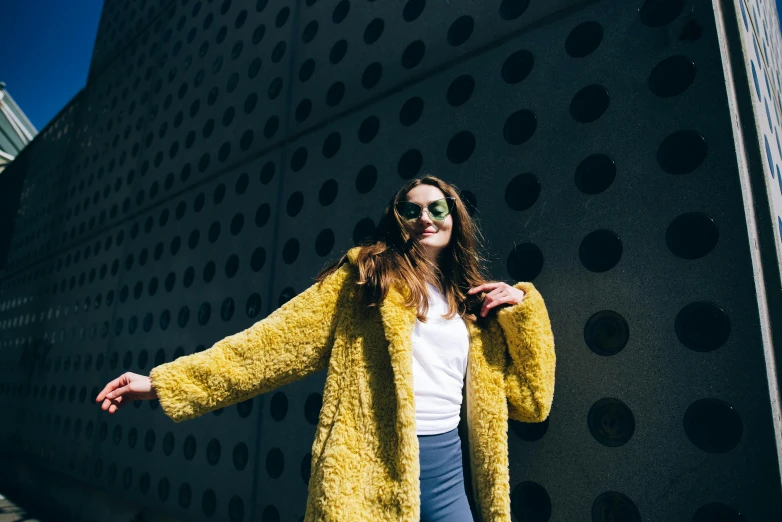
xmin=150 ymin=247 xmax=555 ymax=522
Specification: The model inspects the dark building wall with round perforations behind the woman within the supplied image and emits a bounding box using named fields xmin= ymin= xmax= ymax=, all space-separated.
xmin=0 ymin=0 xmax=782 ymax=522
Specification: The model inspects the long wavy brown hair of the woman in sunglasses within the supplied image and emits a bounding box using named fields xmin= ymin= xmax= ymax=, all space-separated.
xmin=315 ymin=174 xmax=488 ymax=322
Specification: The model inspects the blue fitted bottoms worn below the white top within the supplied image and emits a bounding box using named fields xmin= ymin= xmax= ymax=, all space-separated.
xmin=418 ymin=428 xmax=474 ymax=522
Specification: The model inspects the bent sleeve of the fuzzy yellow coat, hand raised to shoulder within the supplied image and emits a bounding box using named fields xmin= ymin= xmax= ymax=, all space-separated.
xmin=497 ymin=282 xmax=556 ymax=422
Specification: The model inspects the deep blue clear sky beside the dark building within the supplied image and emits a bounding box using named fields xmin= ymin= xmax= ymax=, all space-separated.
xmin=0 ymin=0 xmax=782 ymax=131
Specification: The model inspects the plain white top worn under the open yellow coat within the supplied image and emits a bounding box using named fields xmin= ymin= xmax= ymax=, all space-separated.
xmin=412 ymin=283 xmax=470 ymax=435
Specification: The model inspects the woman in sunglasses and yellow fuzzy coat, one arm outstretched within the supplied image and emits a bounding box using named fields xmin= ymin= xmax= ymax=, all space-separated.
xmin=96 ymin=176 xmax=556 ymax=522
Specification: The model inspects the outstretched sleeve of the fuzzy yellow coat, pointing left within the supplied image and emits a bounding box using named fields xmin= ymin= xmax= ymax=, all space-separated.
xmin=149 ymin=263 xmax=353 ymax=422
